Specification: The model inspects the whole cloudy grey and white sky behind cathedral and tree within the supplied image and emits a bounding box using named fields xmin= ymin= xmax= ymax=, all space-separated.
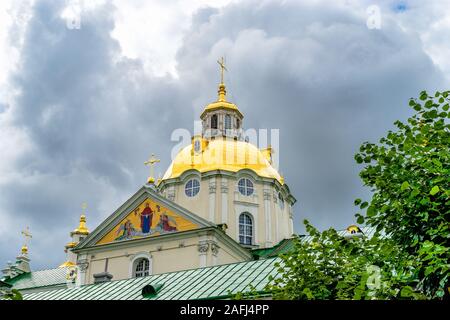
xmin=0 ymin=0 xmax=450 ymax=270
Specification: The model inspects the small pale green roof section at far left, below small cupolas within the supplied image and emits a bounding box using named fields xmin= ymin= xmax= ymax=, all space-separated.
xmin=4 ymin=268 xmax=66 ymax=290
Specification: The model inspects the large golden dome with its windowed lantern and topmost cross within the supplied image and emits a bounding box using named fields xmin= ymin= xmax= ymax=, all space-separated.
xmin=162 ymin=58 xmax=284 ymax=185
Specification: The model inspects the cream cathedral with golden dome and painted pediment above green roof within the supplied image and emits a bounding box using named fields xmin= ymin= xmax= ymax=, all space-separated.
xmin=2 ymin=61 xmax=302 ymax=298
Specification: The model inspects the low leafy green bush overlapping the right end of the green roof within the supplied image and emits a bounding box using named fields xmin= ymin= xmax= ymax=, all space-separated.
xmin=267 ymin=220 xmax=414 ymax=300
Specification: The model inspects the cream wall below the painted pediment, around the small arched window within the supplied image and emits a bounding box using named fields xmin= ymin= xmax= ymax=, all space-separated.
xmin=78 ymin=230 xmax=251 ymax=284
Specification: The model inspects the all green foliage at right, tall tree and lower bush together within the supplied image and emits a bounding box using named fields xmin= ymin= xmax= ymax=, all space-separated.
xmin=262 ymin=91 xmax=450 ymax=299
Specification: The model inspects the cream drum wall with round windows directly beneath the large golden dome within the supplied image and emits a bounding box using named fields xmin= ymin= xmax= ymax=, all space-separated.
xmin=159 ymin=173 xmax=293 ymax=248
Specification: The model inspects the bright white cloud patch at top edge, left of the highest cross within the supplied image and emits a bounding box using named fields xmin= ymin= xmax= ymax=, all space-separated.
xmin=112 ymin=0 xmax=231 ymax=77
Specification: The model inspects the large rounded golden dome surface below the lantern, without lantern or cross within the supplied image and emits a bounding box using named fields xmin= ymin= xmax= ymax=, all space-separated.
xmin=162 ymin=138 xmax=284 ymax=184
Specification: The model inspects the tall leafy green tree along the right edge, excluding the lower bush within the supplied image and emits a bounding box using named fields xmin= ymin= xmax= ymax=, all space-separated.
xmin=355 ymin=91 xmax=450 ymax=298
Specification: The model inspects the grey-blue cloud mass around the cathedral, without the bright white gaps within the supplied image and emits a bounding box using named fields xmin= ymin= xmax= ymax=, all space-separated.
xmin=0 ymin=1 xmax=443 ymax=268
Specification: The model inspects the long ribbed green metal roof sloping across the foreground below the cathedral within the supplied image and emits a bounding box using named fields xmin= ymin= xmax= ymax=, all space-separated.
xmin=23 ymin=258 xmax=280 ymax=300
